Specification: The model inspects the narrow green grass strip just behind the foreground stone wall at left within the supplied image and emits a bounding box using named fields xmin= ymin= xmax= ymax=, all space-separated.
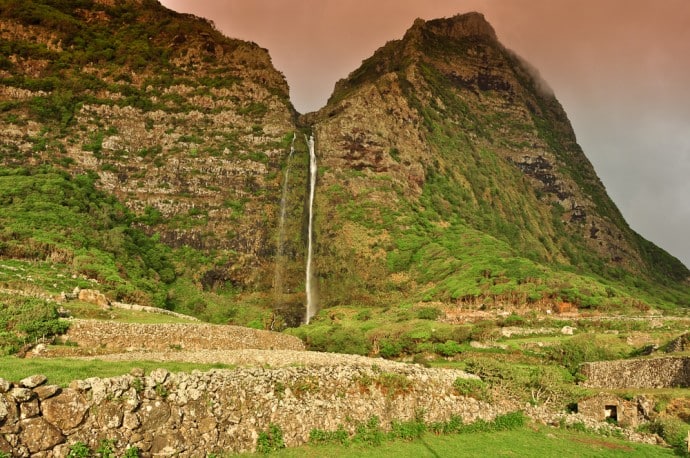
xmin=0 ymin=356 xmax=234 ymax=386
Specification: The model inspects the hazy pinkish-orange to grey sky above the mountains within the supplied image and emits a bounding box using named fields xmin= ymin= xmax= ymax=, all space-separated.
xmin=161 ymin=0 xmax=690 ymax=266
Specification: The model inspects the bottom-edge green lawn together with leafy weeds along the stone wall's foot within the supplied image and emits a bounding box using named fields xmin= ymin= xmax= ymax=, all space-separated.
xmin=236 ymin=414 xmax=676 ymax=458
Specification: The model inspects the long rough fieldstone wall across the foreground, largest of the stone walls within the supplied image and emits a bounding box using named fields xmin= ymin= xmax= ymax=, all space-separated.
xmin=0 ymin=364 xmax=506 ymax=458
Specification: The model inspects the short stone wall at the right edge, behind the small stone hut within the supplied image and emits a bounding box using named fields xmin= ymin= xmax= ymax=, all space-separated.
xmin=580 ymin=357 xmax=690 ymax=388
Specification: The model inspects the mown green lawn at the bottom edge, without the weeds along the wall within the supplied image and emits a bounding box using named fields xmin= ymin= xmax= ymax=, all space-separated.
xmin=236 ymin=427 xmax=676 ymax=458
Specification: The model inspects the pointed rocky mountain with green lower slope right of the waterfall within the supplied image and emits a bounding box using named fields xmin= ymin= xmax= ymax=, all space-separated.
xmin=310 ymin=13 xmax=687 ymax=303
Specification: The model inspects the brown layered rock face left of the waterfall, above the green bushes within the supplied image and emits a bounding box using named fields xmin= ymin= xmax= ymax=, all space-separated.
xmin=0 ymin=0 xmax=294 ymax=284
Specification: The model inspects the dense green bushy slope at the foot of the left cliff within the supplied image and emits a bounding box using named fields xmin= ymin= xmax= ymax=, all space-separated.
xmin=0 ymin=167 xmax=176 ymax=305
